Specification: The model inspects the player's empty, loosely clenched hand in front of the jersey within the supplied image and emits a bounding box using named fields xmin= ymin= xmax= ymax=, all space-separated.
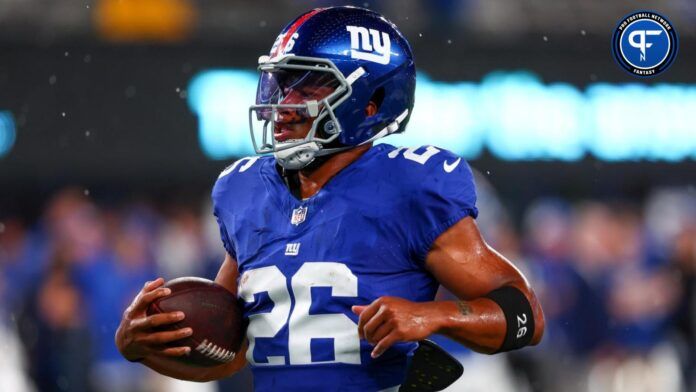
xmin=352 ymin=297 xmax=444 ymax=358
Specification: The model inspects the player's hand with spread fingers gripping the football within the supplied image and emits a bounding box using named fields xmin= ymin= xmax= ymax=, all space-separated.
xmin=115 ymin=278 xmax=193 ymax=361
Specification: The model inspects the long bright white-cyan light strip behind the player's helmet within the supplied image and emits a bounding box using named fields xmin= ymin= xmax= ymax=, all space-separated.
xmin=188 ymin=70 xmax=696 ymax=161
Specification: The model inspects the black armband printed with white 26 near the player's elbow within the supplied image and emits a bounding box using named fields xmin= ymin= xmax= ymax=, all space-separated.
xmin=485 ymin=286 xmax=534 ymax=353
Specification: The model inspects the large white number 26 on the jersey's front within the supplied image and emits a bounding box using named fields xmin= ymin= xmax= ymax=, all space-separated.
xmin=239 ymin=262 xmax=360 ymax=365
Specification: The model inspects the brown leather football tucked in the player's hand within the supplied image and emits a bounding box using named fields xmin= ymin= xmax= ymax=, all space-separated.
xmin=147 ymin=277 xmax=246 ymax=367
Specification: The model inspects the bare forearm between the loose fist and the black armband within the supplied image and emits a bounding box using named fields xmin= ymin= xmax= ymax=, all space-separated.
xmin=433 ymin=298 xmax=506 ymax=354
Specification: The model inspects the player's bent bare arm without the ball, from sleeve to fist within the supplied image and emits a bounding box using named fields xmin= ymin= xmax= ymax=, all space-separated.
xmin=354 ymin=217 xmax=544 ymax=356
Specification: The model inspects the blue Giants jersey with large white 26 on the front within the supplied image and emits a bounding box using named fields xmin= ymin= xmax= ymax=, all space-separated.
xmin=213 ymin=144 xmax=477 ymax=391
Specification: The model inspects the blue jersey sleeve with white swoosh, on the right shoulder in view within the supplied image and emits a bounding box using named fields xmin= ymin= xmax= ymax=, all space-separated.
xmin=409 ymin=150 xmax=478 ymax=262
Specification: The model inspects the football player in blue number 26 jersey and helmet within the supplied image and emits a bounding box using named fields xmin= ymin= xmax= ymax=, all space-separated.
xmin=116 ymin=7 xmax=544 ymax=391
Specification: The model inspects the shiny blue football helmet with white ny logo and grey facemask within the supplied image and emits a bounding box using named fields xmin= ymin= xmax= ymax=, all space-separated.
xmin=249 ymin=7 xmax=416 ymax=170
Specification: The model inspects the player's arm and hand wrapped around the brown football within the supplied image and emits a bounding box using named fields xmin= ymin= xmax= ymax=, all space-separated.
xmin=115 ymin=254 xmax=247 ymax=382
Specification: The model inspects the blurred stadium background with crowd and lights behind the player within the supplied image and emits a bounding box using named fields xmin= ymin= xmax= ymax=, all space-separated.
xmin=0 ymin=0 xmax=696 ymax=391
